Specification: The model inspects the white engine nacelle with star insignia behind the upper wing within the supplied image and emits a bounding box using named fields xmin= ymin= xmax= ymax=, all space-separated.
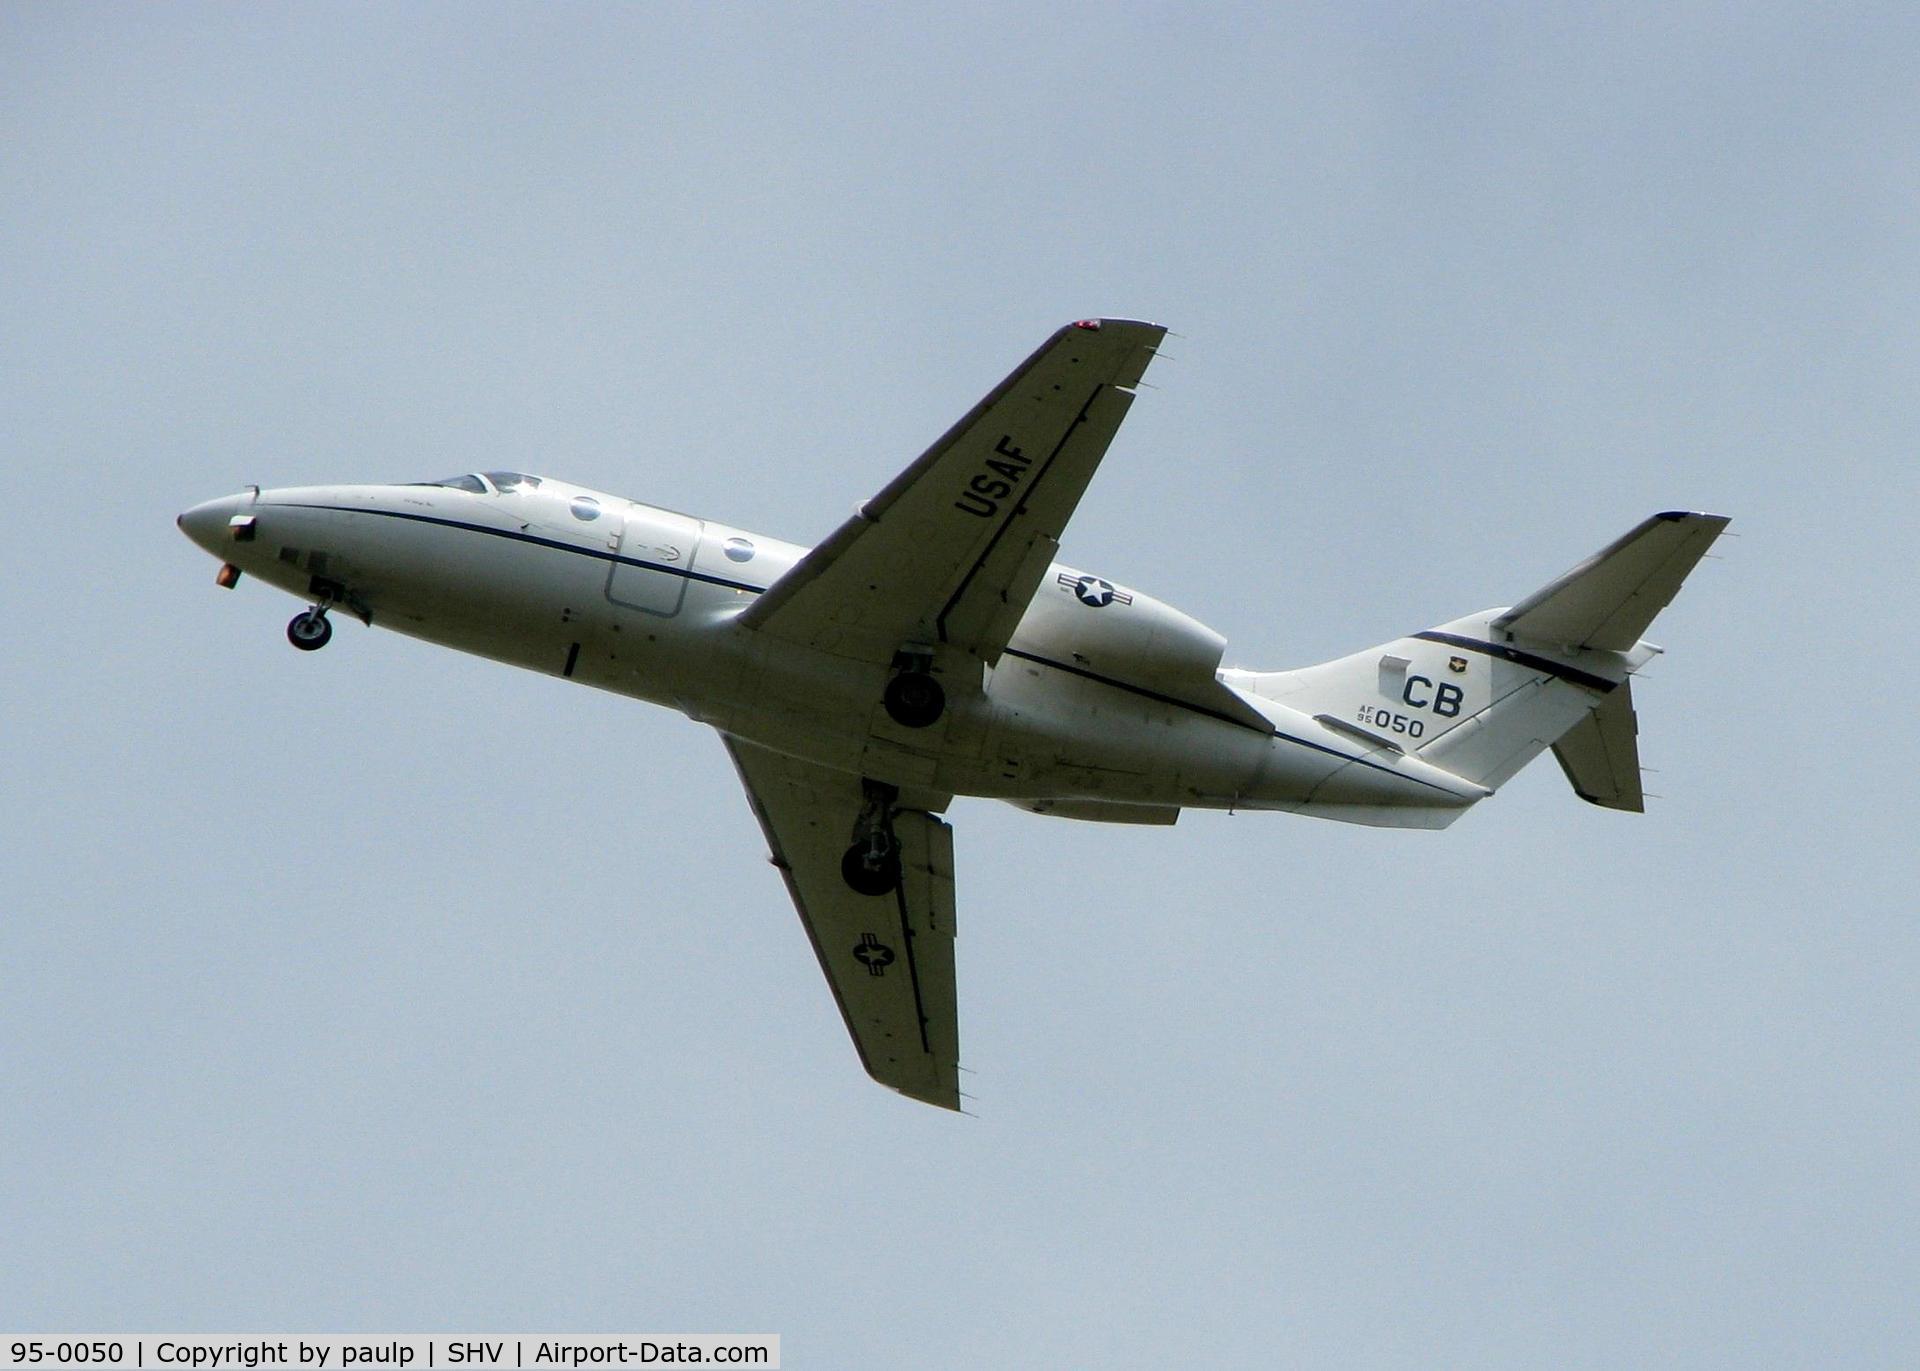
xmin=1008 ymin=565 xmax=1227 ymax=701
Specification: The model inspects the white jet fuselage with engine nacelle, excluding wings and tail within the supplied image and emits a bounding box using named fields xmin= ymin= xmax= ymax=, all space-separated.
xmin=180 ymin=478 xmax=1486 ymax=826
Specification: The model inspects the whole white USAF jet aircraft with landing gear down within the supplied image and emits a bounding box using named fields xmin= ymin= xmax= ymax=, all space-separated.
xmin=179 ymin=319 xmax=1728 ymax=1108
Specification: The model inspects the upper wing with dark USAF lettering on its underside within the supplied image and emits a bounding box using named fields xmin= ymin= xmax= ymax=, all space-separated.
xmin=739 ymin=319 xmax=1167 ymax=662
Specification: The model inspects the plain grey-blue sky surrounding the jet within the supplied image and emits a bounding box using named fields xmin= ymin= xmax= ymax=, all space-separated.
xmin=0 ymin=4 xmax=1920 ymax=1367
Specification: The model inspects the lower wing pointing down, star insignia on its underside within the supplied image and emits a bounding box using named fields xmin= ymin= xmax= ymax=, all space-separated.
xmin=724 ymin=737 xmax=960 ymax=1110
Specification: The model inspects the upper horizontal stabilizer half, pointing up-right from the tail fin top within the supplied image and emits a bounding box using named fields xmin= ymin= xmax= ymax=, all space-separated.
xmin=1494 ymin=513 xmax=1730 ymax=653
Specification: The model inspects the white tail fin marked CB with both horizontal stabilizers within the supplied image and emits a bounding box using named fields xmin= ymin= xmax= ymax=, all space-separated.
xmin=1221 ymin=513 xmax=1728 ymax=828
